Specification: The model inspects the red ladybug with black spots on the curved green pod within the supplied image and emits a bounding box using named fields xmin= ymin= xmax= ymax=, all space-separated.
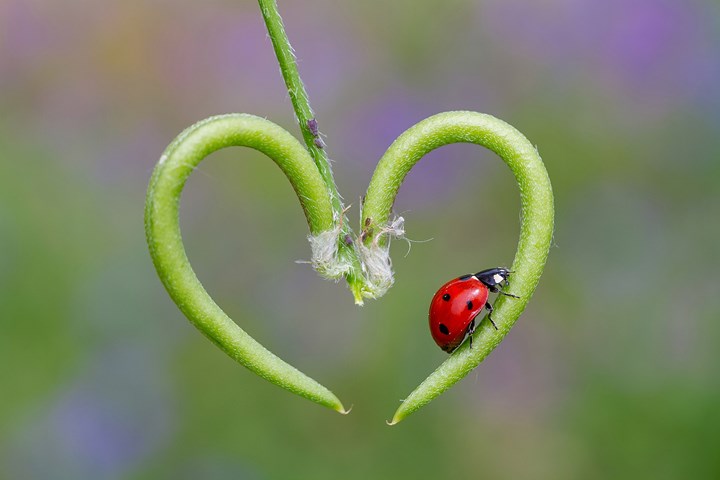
xmin=428 ymin=267 xmax=520 ymax=353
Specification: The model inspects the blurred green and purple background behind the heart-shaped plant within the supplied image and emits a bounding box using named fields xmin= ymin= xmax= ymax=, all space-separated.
xmin=0 ymin=0 xmax=720 ymax=480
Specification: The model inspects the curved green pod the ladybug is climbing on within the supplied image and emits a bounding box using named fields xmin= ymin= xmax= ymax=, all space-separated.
xmin=363 ymin=112 xmax=553 ymax=425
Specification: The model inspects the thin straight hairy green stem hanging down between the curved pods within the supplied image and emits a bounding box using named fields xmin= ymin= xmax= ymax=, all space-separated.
xmin=258 ymin=0 xmax=364 ymax=305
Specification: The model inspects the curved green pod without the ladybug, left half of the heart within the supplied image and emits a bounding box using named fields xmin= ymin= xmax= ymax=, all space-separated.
xmin=145 ymin=114 xmax=345 ymax=413
